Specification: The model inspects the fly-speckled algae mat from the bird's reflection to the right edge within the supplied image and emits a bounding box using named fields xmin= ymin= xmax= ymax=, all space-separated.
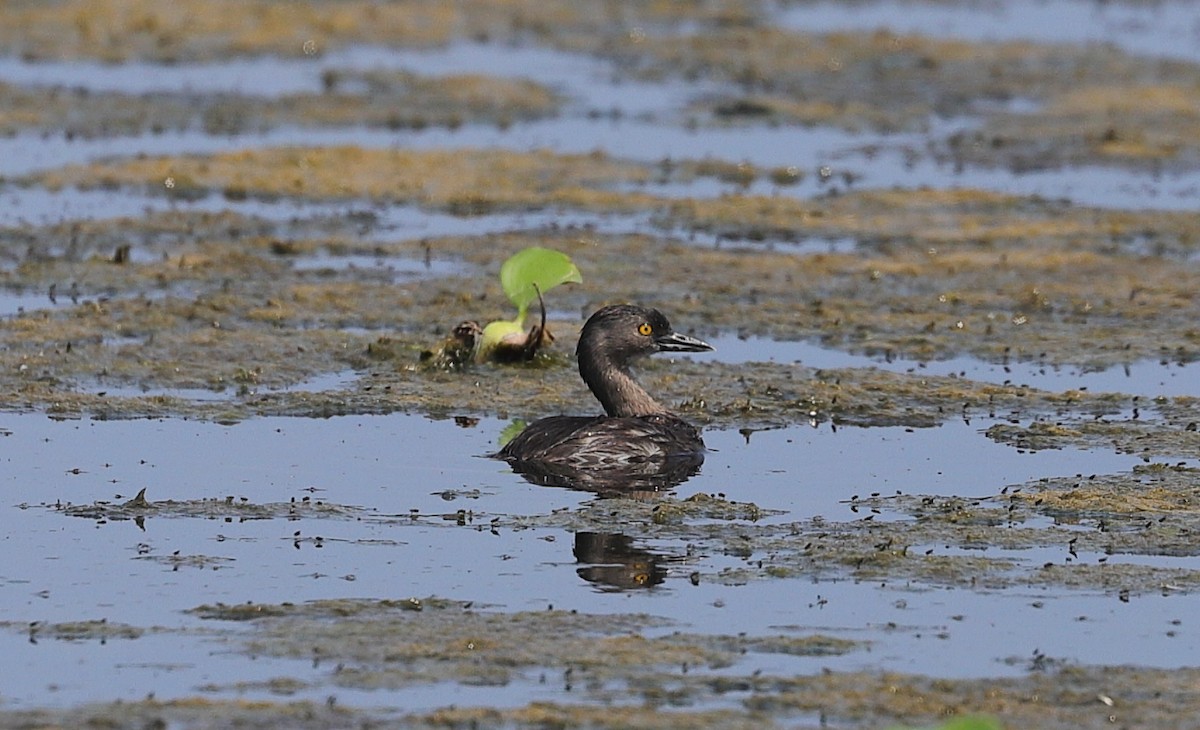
xmin=681 ymin=475 xmax=1200 ymax=600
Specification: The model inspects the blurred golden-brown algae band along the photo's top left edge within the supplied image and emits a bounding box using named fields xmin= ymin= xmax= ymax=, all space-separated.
xmin=0 ymin=0 xmax=754 ymax=62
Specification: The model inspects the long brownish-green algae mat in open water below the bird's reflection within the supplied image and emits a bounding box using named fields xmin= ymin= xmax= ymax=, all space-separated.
xmin=184 ymin=599 xmax=863 ymax=693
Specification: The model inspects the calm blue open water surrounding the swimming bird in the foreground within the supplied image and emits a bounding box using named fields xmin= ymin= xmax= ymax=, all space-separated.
xmin=0 ymin=414 xmax=1200 ymax=707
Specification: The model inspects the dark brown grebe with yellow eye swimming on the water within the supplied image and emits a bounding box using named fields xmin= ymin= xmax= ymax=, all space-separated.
xmin=496 ymin=304 xmax=713 ymax=468
